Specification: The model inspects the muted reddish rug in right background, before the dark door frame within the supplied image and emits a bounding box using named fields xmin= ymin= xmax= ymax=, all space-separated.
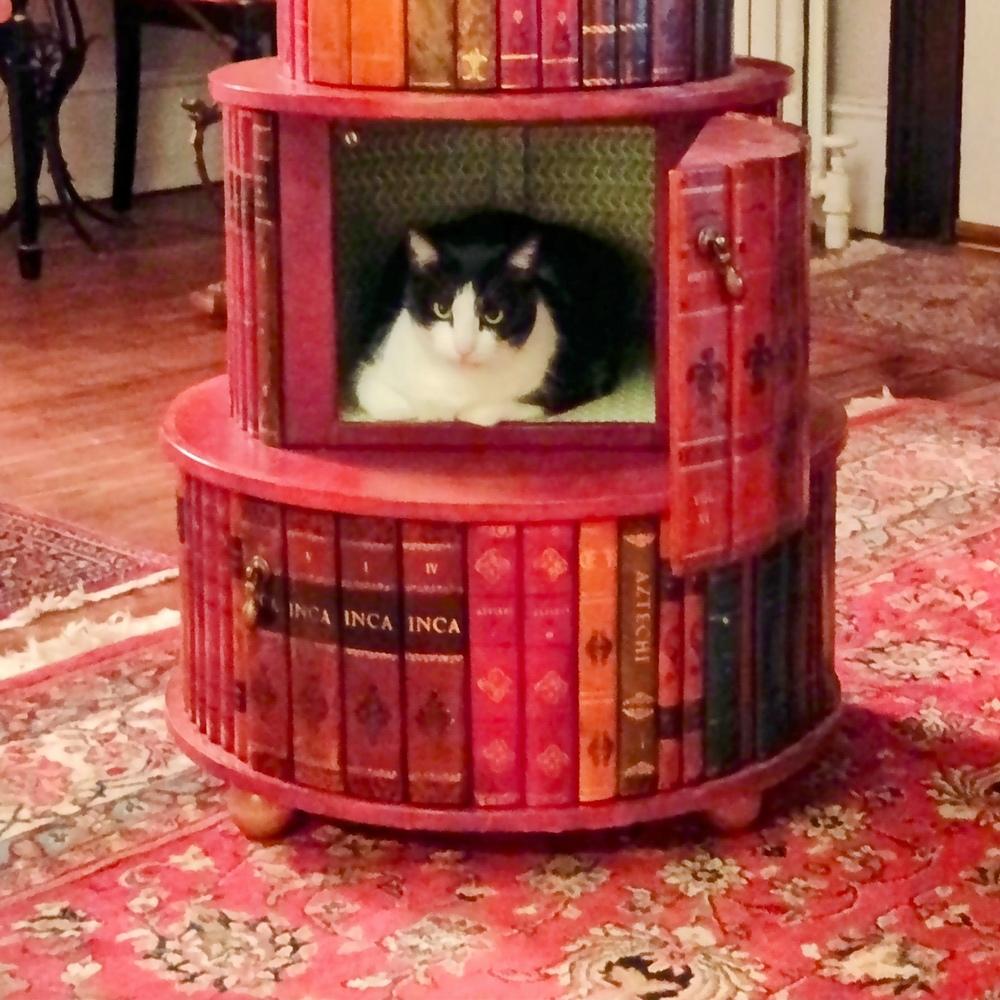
xmin=812 ymin=247 xmax=1000 ymax=375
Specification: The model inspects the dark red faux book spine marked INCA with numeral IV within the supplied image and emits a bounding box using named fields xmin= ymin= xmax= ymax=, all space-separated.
xmin=402 ymin=523 xmax=469 ymax=805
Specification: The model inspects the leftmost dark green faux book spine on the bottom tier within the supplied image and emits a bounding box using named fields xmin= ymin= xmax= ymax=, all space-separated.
xmin=705 ymin=566 xmax=743 ymax=777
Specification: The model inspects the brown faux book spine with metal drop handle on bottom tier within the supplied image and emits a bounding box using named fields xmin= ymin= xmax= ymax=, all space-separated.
xmin=234 ymin=497 xmax=292 ymax=780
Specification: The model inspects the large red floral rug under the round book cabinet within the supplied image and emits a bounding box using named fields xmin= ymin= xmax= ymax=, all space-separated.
xmin=0 ymin=405 xmax=1000 ymax=1000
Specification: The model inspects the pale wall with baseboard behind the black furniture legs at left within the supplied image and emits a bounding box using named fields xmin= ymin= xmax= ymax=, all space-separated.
xmin=0 ymin=0 xmax=226 ymax=210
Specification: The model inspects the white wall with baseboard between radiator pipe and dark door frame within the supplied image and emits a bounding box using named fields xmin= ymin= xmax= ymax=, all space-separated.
xmin=830 ymin=0 xmax=892 ymax=233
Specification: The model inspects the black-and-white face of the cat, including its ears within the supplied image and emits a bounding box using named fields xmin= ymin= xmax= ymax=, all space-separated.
xmin=405 ymin=232 xmax=539 ymax=366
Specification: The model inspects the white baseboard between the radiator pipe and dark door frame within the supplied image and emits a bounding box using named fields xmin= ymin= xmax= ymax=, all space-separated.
xmin=830 ymin=95 xmax=889 ymax=233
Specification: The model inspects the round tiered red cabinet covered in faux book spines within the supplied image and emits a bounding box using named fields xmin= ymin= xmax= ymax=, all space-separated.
xmin=164 ymin=0 xmax=845 ymax=836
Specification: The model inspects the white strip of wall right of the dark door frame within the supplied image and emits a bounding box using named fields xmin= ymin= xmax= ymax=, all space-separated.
xmin=958 ymin=0 xmax=1000 ymax=227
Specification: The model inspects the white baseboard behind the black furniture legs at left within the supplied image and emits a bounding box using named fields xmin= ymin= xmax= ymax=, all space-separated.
xmin=0 ymin=70 xmax=222 ymax=210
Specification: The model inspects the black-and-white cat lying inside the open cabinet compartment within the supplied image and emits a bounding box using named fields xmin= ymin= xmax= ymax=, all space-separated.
xmin=354 ymin=212 xmax=643 ymax=427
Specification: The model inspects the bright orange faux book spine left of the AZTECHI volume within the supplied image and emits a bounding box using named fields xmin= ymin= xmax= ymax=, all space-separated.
xmin=577 ymin=521 xmax=619 ymax=802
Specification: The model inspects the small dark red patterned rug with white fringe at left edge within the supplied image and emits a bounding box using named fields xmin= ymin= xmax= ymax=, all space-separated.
xmin=0 ymin=502 xmax=174 ymax=626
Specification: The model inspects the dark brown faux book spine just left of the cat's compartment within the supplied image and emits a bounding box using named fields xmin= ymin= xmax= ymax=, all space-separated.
xmin=252 ymin=112 xmax=282 ymax=446
